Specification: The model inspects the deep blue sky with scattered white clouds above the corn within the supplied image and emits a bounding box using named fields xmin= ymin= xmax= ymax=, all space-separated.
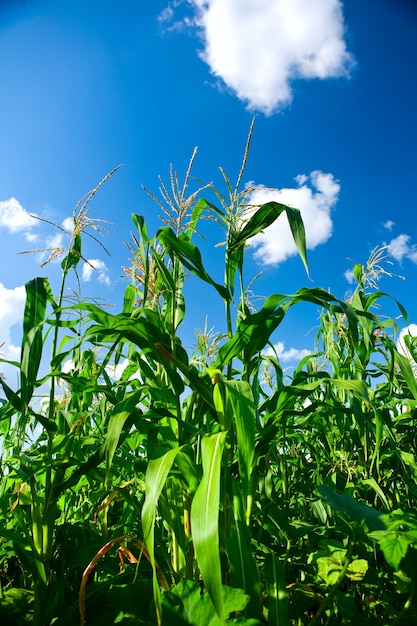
xmin=0 ymin=0 xmax=417 ymax=378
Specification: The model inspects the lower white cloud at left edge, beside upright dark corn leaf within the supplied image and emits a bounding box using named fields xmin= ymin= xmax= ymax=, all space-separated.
xmin=0 ymin=283 xmax=26 ymax=388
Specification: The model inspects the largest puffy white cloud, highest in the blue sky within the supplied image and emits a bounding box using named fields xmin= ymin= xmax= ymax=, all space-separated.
xmin=184 ymin=0 xmax=353 ymax=114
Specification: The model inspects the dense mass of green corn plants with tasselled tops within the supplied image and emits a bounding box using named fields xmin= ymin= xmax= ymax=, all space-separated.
xmin=0 ymin=138 xmax=417 ymax=626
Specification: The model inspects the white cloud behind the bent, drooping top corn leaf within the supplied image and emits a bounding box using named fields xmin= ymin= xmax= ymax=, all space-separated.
xmin=249 ymin=171 xmax=340 ymax=265
